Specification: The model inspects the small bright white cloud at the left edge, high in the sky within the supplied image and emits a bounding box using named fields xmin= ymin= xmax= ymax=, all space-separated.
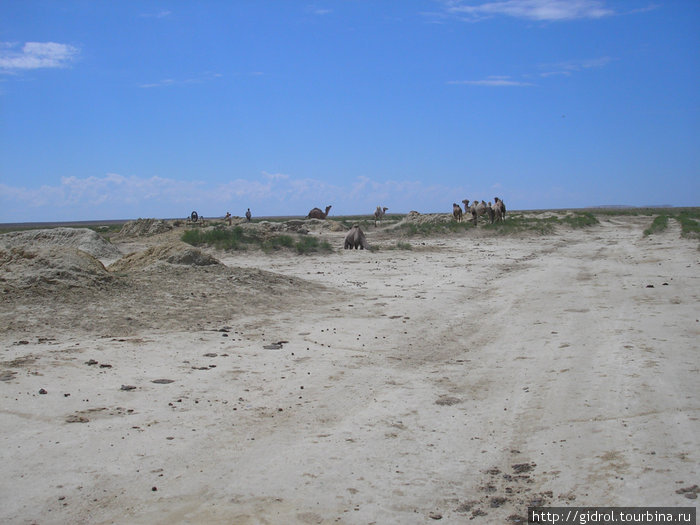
xmin=0 ymin=42 xmax=80 ymax=72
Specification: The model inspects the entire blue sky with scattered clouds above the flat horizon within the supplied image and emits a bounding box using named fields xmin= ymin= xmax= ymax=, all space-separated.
xmin=0 ymin=0 xmax=700 ymax=222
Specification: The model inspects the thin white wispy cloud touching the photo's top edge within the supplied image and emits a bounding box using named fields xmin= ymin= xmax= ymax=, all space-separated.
xmin=444 ymin=0 xmax=615 ymax=22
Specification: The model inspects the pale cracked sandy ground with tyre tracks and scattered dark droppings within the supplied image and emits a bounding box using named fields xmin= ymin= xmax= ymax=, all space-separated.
xmin=0 ymin=216 xmax=700 ymax=524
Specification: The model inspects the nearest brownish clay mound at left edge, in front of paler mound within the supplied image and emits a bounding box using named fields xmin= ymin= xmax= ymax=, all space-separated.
xmin=0 ymin=246 xmax=112 ymax=295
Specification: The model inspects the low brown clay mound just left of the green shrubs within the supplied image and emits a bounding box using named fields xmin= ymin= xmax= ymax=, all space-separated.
xmin=109 ymin=242 xmax=221 ymax=272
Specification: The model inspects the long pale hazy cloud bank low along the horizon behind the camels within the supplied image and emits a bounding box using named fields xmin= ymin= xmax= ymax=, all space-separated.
xmin=0 ymin=172 xmax=491 ymax=222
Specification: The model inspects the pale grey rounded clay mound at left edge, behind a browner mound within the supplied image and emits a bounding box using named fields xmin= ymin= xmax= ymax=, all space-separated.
xmin=0 ymin=228 xmax=121 ymax=259
